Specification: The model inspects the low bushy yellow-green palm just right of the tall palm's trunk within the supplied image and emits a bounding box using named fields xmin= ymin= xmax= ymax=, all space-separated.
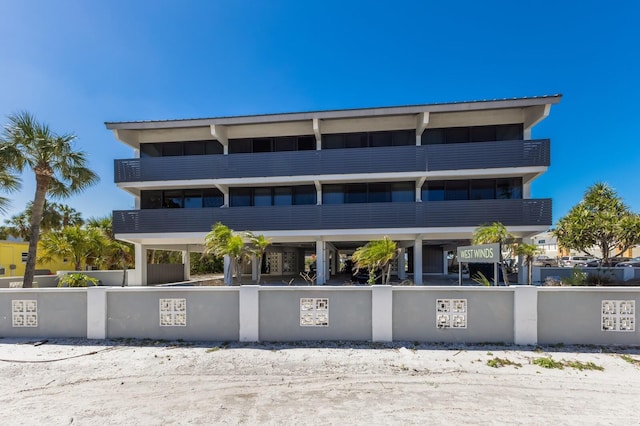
xmin=38 ymin=226 xmax=109 ymax=271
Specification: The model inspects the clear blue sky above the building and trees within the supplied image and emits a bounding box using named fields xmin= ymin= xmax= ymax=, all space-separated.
xmin=0 ymin=0 xmax=640 ymax=223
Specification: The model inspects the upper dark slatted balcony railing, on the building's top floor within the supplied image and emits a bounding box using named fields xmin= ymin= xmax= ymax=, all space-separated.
xmin=114 ymin=139 xmax=550 ymax=183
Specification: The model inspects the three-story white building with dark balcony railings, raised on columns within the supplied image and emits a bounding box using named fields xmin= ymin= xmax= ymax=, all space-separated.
xmin=106 ymin=95 xmax=561 ymax=284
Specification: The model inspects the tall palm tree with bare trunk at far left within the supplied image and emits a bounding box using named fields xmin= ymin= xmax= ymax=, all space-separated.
xmin=0 ymin=112 xmax=98 ymax=288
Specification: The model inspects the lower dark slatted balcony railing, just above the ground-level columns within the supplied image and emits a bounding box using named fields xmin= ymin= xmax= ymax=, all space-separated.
xmin=113 ymin=199 xmax=551 ymax=234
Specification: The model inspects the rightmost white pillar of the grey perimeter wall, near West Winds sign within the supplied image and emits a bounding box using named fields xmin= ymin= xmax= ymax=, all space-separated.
xmin=511 ymin=286 xmax=538 ymax=345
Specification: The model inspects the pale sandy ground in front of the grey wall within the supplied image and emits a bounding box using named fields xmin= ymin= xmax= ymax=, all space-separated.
xmin=0 ymin=338 xmax=640 ymax=425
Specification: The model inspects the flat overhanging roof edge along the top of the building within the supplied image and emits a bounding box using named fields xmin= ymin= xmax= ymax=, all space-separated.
xmin=105 ymin=94 xmax=562 ymax=130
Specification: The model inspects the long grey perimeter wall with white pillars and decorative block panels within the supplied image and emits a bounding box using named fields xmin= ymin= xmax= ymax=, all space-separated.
xmin=0 ymin=285 xmax=640 ymax=345
